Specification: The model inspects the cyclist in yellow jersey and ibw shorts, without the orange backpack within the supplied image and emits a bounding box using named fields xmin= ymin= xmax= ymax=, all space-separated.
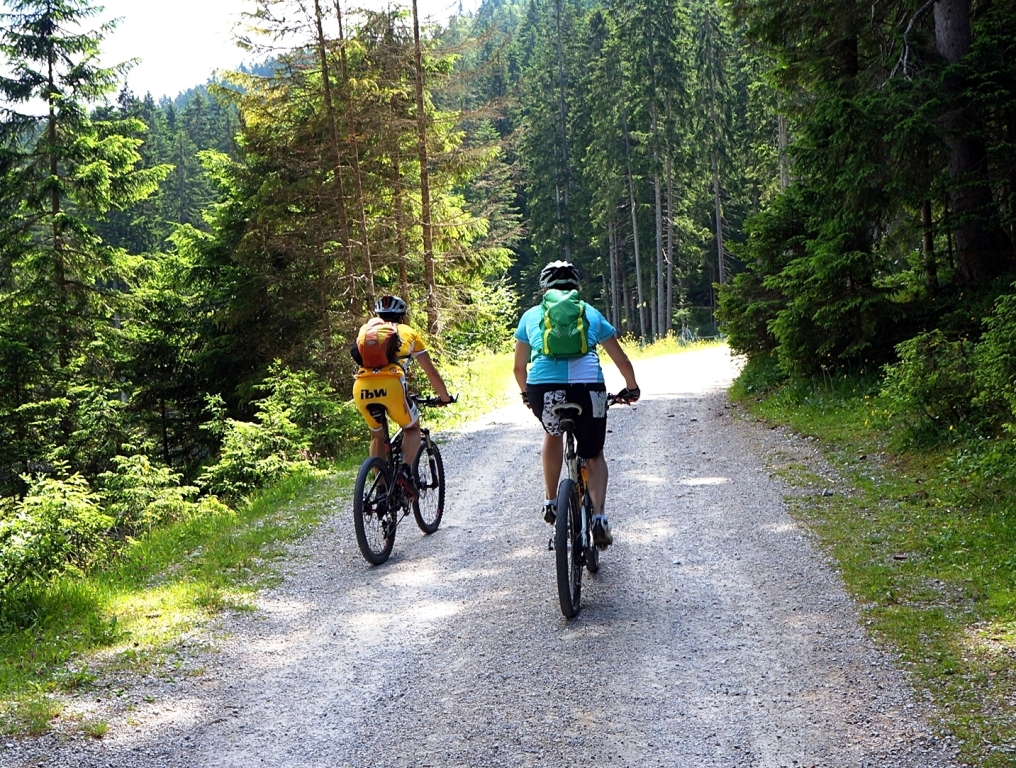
xmin=350 ymin=296 xmax=452 ymax=499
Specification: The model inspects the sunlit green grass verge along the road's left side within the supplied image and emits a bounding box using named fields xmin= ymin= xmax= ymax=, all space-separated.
xmin=0 ymin=471 xmax=353 ymax=738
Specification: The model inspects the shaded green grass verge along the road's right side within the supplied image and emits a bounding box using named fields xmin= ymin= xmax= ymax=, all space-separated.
xmin=735 ymin=380 xmax=1016 ymax=768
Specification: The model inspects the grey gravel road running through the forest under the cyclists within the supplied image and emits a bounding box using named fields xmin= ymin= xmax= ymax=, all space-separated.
xmin=0 ymin=347 xmax=958 ymax=768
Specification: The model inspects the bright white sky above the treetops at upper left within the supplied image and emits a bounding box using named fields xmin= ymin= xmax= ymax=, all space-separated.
xmin=96 ymin=0 xmax=479 ymax=101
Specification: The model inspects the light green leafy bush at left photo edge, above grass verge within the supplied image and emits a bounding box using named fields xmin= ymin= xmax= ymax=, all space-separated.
xmin=0 ymin=474 xmax=113 ymax=595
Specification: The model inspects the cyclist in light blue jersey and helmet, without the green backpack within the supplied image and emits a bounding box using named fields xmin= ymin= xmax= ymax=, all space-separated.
xmin=514 ymin=261 xmax=640 ymax=547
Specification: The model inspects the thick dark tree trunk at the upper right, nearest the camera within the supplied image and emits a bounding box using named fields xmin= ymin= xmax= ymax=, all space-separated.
xmin=935 ymin=0 xmax=1012 ymax=282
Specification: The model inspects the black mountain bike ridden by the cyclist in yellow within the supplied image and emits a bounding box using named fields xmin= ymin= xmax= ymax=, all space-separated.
xmin=353 ymin=395 xmax=456 ymax=565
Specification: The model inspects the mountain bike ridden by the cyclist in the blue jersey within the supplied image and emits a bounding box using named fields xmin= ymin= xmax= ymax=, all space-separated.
xmin=551 ymin=395 xmax=622 ymax=619
